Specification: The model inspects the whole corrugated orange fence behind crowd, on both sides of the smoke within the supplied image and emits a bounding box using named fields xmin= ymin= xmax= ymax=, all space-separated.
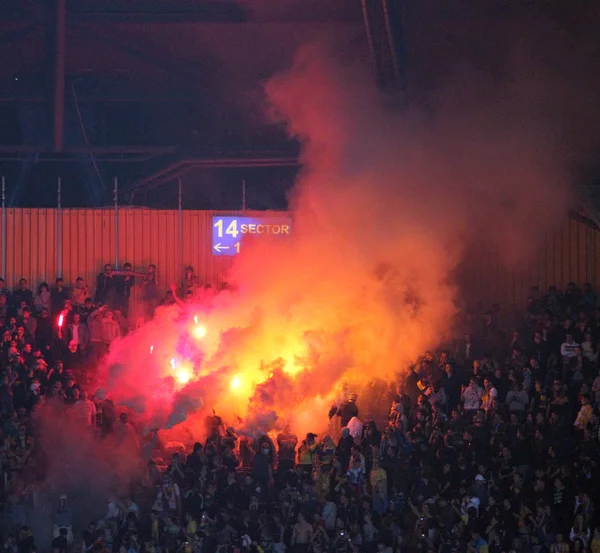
xmin=0 ymin=208 xmax=600 ymax=305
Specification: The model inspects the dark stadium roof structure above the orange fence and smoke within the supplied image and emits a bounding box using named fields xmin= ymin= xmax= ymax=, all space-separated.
xmin=0 ymin=0 xmax=591 ymax=207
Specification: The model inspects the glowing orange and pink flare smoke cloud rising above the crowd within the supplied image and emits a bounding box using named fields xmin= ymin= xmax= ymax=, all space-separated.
xmin=97 ymin=40 xmax=567 ymax=437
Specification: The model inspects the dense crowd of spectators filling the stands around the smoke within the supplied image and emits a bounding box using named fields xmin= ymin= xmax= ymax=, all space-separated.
xmin=0 ymin=274 xmax=600 ymax=553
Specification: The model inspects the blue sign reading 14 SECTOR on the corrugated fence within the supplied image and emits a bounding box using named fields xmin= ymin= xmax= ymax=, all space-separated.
xmin=212 ymin=216 xmax=292 ymax=255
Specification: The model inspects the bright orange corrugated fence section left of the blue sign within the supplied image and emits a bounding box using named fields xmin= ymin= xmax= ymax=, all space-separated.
xmin=0 ymin=208 xmax=282 ymax=310
